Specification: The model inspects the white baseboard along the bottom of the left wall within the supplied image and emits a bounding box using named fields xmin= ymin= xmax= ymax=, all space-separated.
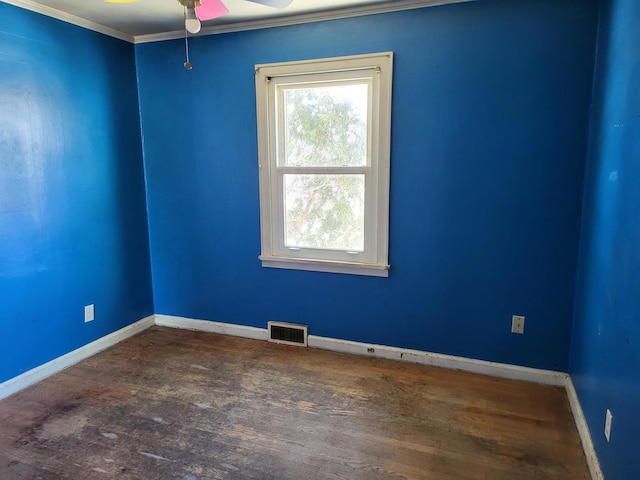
xmin=0 ymin=315 xmax=155 ymax=400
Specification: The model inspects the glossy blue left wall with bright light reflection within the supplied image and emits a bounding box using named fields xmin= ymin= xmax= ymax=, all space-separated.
xmin=0 ymin=3 xmax=153 ymax=382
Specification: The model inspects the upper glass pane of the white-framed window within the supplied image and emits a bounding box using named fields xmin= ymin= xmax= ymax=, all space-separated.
xmin=284 ymin=83 xmax=369 ymax=167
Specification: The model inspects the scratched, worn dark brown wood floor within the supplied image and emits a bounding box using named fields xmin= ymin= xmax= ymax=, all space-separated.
xmin=0 ymin=327 xmax=589 ymax=480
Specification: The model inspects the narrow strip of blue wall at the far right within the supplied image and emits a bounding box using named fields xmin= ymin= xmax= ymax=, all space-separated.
xmin=570 ymin=0 xmax=640 ymax=480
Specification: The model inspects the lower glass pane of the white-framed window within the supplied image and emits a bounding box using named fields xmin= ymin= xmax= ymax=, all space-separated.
xmin=284 ymin=174 xmax=364 ymax=252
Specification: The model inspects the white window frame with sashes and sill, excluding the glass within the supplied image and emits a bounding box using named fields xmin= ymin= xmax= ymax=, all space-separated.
xmin=255 ymin=52 xmax=393 ymax=277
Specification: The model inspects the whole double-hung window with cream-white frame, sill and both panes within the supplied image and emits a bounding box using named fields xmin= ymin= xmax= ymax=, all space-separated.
xmin=256 ymin=52 xmax=393 ymax=277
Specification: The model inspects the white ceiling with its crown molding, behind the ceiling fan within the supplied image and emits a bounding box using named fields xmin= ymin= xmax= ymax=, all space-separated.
xmin=0 ymin=0 xmax=469 ymax=42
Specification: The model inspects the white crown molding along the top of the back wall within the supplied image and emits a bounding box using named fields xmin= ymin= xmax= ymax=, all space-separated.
xmin=134 ymin=0 xmax=476 ymax=44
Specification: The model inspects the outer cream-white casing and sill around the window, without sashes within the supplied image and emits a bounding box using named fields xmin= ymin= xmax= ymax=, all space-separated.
xmin=255 ymin=52 xmax=393 ymax=277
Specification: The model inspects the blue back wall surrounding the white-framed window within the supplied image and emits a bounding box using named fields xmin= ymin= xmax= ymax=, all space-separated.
xmin=136 ymin=0 xmax=597 ymax=370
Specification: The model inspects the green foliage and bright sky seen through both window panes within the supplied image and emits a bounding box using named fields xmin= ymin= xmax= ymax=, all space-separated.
xmin=284 ymin=84 xmax=368 ymax=251
